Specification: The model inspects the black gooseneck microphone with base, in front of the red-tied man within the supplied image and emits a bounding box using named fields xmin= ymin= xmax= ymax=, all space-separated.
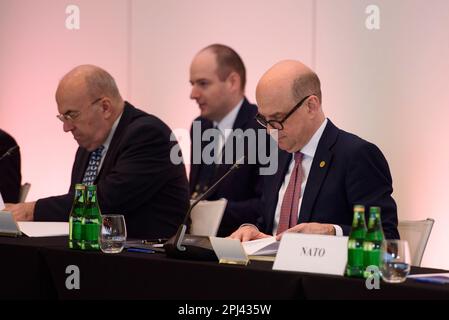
xmin=164 ymin=156 xmax=245 ymax=261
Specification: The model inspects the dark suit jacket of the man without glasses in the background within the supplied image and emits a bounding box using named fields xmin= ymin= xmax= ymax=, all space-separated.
xmin=190 ymin=99 xmax=263 ymax=236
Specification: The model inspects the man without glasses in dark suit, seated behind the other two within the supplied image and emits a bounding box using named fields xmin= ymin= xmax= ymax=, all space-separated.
xmin=186 ymin=44 xmax=263 ymax=236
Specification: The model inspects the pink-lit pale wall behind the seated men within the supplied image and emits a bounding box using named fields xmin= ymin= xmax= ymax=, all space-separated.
xmin=0 ymin=0 xmax=449 ymax=269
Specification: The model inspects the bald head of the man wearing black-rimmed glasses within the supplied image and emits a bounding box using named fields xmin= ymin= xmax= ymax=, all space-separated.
xmin=256 ymin=60 xmax=325 ymax=152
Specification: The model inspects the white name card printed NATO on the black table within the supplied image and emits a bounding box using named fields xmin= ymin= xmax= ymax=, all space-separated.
xmin=273 ymin=233 xmax=348 ymax=276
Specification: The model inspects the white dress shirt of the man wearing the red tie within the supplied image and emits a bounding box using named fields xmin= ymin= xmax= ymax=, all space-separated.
xmin=273 ymin=119 xmax=343 ymax=236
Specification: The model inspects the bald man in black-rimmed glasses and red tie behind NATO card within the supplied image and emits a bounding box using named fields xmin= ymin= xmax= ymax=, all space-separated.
xmin=231 ymin=61 xmax=399 ymax=241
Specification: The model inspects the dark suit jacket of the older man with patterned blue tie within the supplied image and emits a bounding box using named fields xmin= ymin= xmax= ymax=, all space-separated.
xmin=34 ymin=103 xmax=189 ymax=238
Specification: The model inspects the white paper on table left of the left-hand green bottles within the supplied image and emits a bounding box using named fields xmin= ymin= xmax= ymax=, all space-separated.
xmin=17 ymin=221 xmax=69 ymax=237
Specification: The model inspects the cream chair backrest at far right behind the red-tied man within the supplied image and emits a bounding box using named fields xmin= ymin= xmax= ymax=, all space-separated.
xmin=398 ymin=218 xmax=435 ymax=267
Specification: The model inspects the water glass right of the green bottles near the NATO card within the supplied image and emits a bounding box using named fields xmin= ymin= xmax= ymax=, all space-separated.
xmin=380 ymin=240 xmax=410 ymax=283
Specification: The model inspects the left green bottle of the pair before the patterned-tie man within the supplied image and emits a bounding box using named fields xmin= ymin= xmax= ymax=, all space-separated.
xmin=69 ymin=184 xmax=86 ymax=249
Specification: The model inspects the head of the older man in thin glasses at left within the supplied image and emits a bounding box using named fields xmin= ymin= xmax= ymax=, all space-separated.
xmin=56 ymin=65 xmax=124 ymax=151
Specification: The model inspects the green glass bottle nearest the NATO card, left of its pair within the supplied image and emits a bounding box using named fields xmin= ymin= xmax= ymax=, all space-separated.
xmin=346 ymin=205 xmax=366 ymax=277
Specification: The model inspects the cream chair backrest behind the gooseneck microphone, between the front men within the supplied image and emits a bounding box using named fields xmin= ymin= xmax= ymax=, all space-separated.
xmin=190 ymin=199 xmax=228 ymax=237
